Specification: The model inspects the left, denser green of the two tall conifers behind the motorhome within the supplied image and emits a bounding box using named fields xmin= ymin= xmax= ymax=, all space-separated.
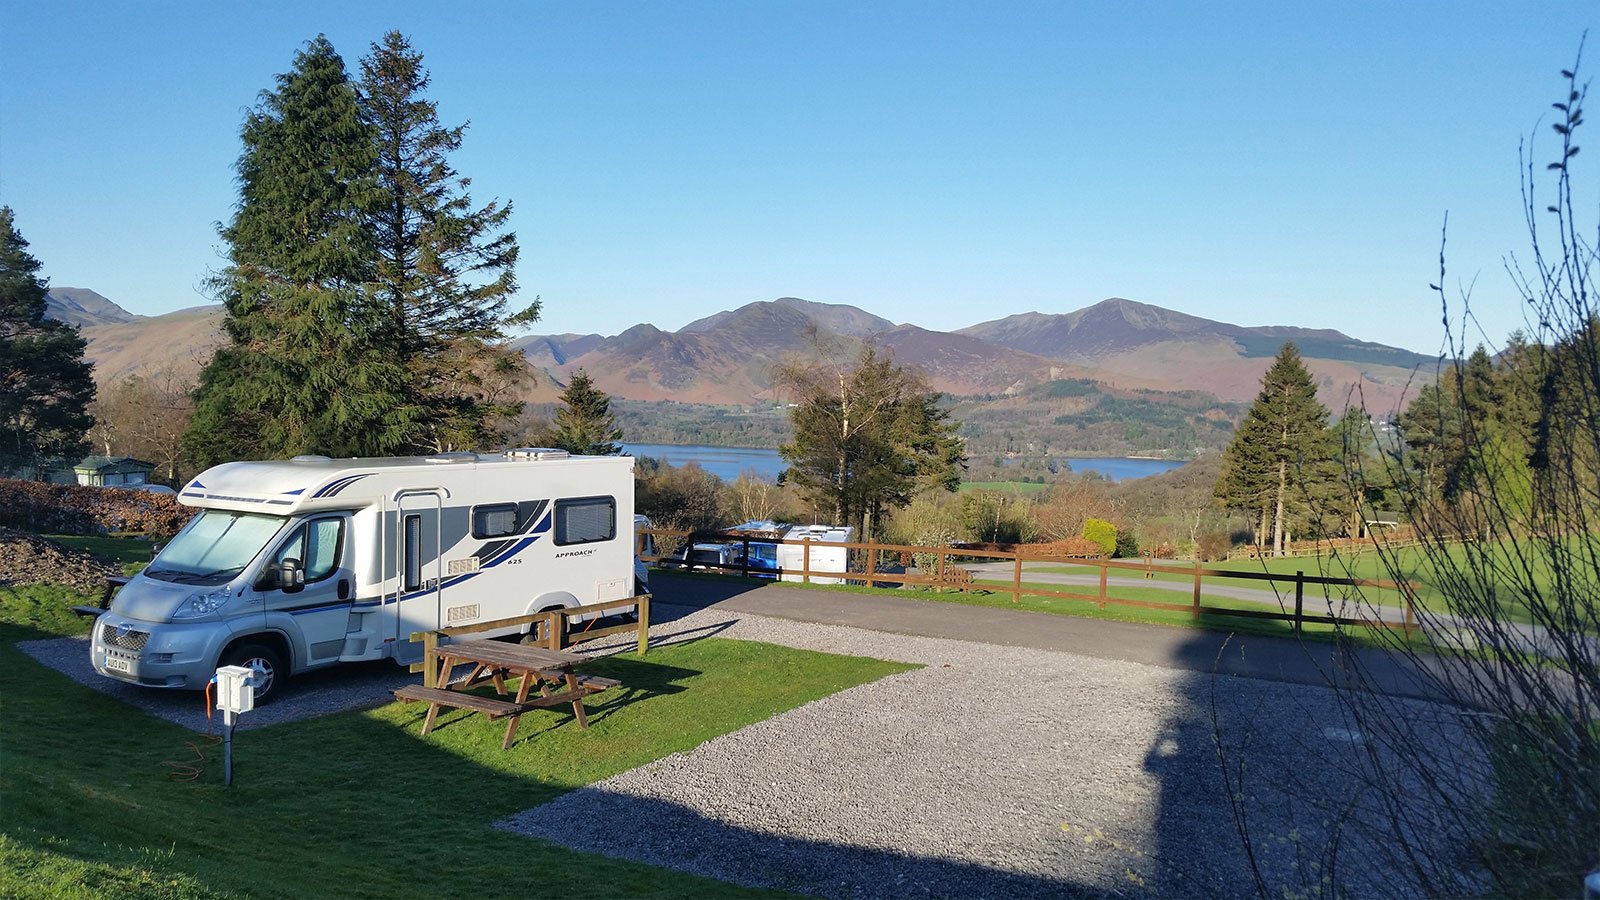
xmin=186 ymin=35 xmax=421 ymax=464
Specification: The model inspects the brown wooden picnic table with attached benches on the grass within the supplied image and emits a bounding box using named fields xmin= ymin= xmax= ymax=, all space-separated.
xmin=394 ymin=641 xmax=619 ymax=749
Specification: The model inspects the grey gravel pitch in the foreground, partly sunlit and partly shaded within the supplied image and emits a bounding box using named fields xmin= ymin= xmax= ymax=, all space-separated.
xmin=499 ymin=609 xmax=1465 ymax=897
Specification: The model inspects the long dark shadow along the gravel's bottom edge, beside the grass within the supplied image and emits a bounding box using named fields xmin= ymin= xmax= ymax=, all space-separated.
xmin=496 ymin=788 xmax=1106 ymax=898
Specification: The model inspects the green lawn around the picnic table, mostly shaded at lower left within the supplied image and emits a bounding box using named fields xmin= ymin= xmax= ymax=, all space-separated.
xmin=0 ymin=570 xmax=910 ymax=898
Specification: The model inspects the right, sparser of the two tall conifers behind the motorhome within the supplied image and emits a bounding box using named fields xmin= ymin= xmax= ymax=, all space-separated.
xmin=358 ymin=32 xmax=539 ymax=450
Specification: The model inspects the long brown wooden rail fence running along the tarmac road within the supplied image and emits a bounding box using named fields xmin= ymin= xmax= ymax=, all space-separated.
xmin=640 ymin=528 xmax=1416 ymax=636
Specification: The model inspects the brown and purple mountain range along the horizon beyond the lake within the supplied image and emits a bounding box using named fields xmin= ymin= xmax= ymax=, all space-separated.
xmin=50 ymin=288 xmax=1435 ymax=413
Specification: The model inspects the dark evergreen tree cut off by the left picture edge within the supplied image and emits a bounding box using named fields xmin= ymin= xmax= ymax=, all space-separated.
xmin=0 ymin=207 xmax=94 ymax=479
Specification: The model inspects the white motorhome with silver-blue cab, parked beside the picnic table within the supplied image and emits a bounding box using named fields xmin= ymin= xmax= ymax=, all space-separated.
xmin=90 ymin=448 xmax=645 ymax=700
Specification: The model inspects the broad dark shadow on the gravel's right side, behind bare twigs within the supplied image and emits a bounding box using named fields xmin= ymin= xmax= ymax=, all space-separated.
xmin=1144 ymin=633 xmax=1454 ymax=897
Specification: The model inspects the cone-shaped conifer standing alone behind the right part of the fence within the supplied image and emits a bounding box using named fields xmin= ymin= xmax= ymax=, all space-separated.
xmin=1216 ymin=343 xmax=1339 ymax=556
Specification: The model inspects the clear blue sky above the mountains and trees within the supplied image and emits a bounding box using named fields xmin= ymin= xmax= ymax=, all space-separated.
xmin=0 ymin=0 xmax=1600 ymax=352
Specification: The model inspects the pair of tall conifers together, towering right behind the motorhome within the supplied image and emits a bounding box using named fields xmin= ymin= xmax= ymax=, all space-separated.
xmin=184 ymin=32 xmax=538 ymax=466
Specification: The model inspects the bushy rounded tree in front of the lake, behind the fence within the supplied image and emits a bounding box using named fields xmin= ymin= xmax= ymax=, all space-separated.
xmin=779 ymin=346 xmax=965 ymax=538
